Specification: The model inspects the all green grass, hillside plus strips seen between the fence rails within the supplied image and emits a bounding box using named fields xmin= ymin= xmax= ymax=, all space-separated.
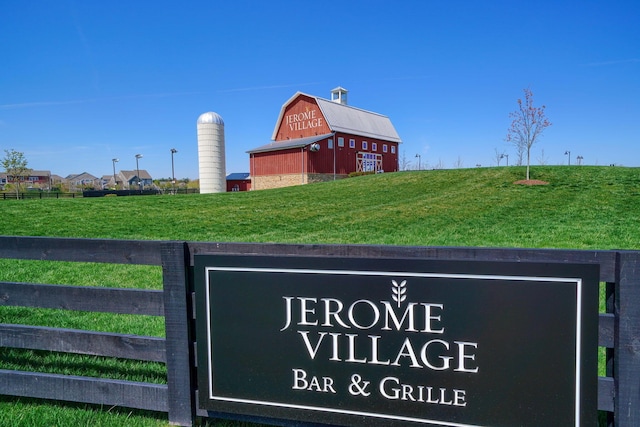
xmin=0 ymin=166 xmax=640 ymax=427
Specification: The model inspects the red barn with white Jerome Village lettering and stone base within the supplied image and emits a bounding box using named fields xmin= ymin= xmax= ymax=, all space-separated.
xmin=248 ymin=87 xmax=401 ymax=190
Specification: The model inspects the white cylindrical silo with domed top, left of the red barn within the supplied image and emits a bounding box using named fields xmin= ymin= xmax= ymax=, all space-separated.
xmin=198 ymin=112 xmax=227 ymax=194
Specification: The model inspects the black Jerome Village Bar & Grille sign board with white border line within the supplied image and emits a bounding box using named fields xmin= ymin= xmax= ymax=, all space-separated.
xmin=195 ymin=255 xmax=599 ymax=427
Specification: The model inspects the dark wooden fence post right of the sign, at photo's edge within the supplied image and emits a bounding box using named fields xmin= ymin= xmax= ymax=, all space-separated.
xmin=614 ymin=251 xmax=640 ymax=427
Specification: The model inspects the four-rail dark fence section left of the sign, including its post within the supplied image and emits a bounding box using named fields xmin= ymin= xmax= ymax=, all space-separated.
xmin=0 ymin=237 xmax=194 ymax=425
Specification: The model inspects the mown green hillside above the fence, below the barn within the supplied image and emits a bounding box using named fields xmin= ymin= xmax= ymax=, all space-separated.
xmin=0 ymin=166 xmax=640 ymax=249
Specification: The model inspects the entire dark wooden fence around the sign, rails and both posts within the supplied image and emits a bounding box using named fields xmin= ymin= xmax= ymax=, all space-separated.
xmin=0 ymin=237 xmax=640 ymax=427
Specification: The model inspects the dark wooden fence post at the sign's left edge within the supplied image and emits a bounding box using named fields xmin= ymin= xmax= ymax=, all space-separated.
xmin=161 ymin=242 xmax=195 ymax=426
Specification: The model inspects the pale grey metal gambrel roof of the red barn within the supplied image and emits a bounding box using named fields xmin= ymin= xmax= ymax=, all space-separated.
xmin=271 ymin=92 xmax=402 ymax=143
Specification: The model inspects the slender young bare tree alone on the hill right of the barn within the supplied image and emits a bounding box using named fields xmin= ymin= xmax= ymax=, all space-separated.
xmin=507 ymin=89 xmax=551 ymax=180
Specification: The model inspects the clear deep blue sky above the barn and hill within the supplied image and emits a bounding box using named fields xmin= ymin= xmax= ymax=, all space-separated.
xmin=0 ymin=0 xmax=640 ymax=179
